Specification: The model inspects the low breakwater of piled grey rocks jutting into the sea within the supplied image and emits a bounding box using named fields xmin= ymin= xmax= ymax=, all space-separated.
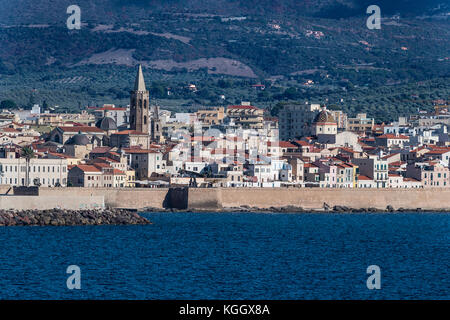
xmin=0 ymin=209 xmax=151 ymax=226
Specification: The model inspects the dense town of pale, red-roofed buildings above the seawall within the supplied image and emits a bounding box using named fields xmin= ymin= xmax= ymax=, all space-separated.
xmin=0 ymin=67 xmax=450 ymax=189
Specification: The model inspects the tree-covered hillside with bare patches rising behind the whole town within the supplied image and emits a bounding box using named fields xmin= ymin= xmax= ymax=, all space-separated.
xmin=0 ymin=0 xmax=450 ymax=120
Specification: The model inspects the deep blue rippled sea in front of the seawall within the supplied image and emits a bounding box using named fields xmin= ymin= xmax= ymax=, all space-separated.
xmin=0 ymin=213 xmax=450 ymax=299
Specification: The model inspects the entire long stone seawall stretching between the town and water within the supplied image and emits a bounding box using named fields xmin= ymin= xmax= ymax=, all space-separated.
xmin=0 ymin=187 xmax=450 ymax=211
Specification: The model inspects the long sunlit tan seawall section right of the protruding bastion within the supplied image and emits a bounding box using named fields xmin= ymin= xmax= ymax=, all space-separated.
xmin=217 ymin=188 xmax=450 ymax=210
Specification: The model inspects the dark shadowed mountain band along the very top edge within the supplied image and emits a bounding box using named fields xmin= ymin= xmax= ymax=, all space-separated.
xmin=0 ymin=0 xmax=450 ymax=24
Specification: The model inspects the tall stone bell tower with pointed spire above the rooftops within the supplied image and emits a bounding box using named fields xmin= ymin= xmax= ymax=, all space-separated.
xmin=130 ymin=65 xmax=150 ymax=133
